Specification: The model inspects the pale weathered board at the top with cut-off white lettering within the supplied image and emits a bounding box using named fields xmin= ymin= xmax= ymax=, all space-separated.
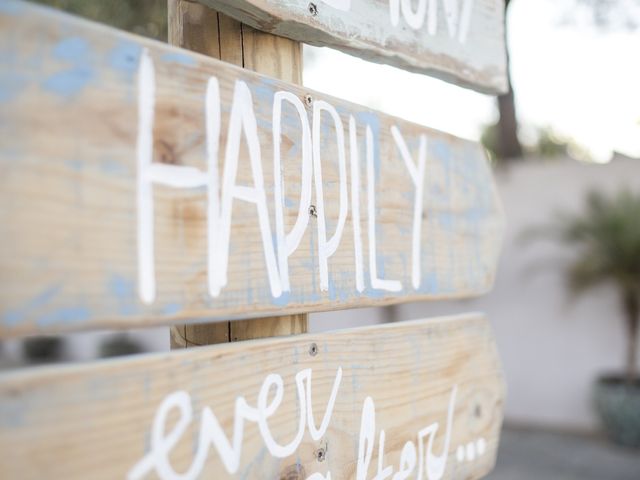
xmin=198 ymin=0 xmax=507 ymax=93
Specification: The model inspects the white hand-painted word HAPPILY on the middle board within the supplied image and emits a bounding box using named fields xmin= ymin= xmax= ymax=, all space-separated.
xmin=137 ymin=51 xmax=427 ymax=303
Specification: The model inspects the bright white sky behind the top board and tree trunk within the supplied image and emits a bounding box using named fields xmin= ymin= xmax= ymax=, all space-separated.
xmin=304 ymin=0 xmax=640 ymax=162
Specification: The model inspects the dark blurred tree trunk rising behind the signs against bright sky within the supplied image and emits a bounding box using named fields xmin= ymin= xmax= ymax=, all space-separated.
xmin=496 ymin=0 xmax=522 ymax=160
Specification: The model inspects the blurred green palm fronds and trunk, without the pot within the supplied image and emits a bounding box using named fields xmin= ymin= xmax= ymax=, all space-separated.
xmin=546 ymin=190 xmax=640 ymax=384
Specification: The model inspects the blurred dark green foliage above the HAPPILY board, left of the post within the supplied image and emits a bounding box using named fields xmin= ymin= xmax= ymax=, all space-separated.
xmin=35 ymin=0 xmax=167 ymax=41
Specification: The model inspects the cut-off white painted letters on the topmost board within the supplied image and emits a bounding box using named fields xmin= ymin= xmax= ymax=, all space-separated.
xmin=322 ymin=0 xmax=474 ymax=43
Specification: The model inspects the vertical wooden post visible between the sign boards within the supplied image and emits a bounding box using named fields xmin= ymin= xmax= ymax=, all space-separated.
xmin=168 ymin=0 xmax=307 ymax=349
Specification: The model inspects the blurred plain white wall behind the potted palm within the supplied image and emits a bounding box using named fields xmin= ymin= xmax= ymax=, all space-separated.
xmin=395 ymin=158 xmax=640 ymax=429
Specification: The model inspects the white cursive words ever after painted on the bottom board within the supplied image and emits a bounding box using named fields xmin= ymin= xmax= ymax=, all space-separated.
xmin=127 ymin=368 xmax=457 ymax=480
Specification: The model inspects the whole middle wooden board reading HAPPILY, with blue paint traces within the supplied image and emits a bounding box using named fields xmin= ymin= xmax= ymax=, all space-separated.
xmin=0 ymin=0 xmax=503 ymax=337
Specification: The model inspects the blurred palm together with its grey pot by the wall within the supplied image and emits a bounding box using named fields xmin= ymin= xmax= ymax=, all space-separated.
xmin=546 ymin=191 xmax=640 ymax=447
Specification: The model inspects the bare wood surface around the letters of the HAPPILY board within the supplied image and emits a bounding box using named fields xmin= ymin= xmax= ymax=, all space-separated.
xmin=0 ymin=0 xmax=503 ymax=337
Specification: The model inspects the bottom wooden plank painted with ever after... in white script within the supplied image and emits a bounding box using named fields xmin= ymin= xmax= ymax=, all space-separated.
xmin=0 ymin=315 xmax=504 ymax=480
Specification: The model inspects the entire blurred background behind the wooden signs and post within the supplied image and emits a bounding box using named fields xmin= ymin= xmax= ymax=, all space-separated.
xmin=0 ymin=0 xmax=640 ymax=480
